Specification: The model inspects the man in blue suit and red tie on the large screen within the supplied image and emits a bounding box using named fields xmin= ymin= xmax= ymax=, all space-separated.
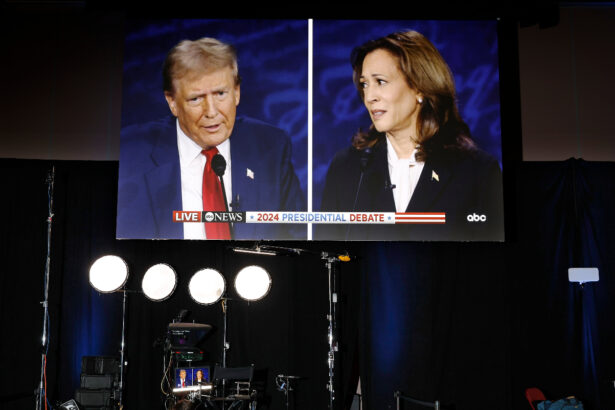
xmin=117 ymin=38 xmax=305 ymax=239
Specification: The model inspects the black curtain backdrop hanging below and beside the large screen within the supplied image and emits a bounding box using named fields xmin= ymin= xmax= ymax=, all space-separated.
xmin=0 ymin=160 xmax=615 ymax=410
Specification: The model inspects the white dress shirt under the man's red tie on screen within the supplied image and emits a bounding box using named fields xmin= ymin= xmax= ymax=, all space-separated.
xmin=176 ymin=121 xmax=233 ymax=239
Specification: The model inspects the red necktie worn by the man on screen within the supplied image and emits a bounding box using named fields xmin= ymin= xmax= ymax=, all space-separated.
xmin=201 ymin=147 xmax=231 ymax=239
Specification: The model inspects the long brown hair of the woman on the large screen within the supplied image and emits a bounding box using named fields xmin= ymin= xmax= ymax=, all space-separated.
xmin=350 ymin=31 xmax=474 ymax=161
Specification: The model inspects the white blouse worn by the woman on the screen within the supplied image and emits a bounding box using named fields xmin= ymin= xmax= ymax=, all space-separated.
xmin=387 ymin=136 xmax=425 ymax=212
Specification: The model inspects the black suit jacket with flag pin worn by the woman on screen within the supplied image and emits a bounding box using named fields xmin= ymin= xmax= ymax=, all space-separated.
xmin=314 ymin=136 xmax=504 ymax=241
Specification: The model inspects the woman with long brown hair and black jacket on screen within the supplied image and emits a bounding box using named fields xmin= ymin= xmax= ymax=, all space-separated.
xmin=317 ymin=31 xmax=503 ymax=241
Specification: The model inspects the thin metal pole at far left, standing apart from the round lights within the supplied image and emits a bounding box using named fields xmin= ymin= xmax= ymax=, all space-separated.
xmin=36 ymin=166 xmax=56 ymax=410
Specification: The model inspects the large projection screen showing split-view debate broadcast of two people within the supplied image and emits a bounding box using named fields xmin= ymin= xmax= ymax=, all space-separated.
xmin=117 ymin=20 xmax=504 ymax=241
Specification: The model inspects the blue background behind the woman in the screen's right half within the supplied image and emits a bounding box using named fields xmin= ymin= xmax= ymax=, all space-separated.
xmin=312 ymin=20 xmax=502 ymax=210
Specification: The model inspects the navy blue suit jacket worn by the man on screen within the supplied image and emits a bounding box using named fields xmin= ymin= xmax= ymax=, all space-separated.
xmin=116 ymin=117 xmax=307 ymax=239
